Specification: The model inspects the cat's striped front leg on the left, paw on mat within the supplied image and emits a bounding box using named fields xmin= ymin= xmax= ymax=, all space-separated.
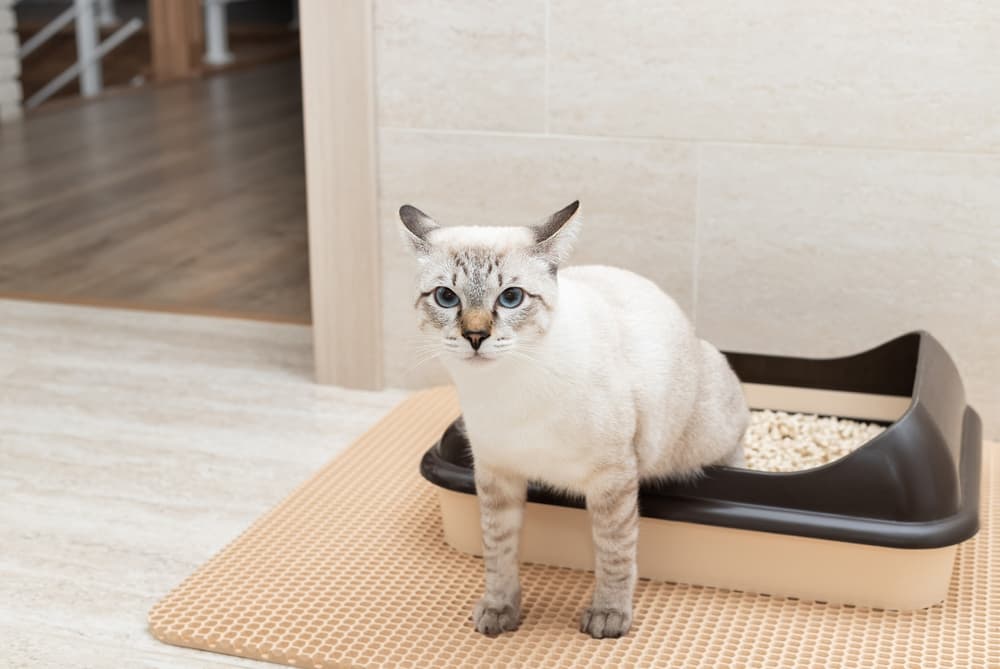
xmin=472 ymin=464 xmax=527 ymax=634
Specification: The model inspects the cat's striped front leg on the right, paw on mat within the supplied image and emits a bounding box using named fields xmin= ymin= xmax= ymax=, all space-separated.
xmin=580 ymin=465 xmax=639 ymax=639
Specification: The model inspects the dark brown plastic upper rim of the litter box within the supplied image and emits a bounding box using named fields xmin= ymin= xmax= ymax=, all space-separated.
xmin=420 ymin=332 xmax=982 ymax=549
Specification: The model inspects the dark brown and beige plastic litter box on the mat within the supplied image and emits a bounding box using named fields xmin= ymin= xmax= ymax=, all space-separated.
xmin=420 ymin=332 xmax=982 ymax=610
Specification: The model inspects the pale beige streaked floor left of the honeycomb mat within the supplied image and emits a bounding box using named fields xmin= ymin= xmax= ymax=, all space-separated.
xmin=0 ymin=300 xmax=404 ymax=667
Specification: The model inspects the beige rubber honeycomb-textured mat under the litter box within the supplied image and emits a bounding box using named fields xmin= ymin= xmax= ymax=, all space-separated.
xmin=149 ymin=389 xmax=1000 ymax=669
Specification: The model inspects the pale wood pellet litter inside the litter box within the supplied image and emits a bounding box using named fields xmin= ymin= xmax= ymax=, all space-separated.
xmin=743 ymin=409 xmax=885 ymax=472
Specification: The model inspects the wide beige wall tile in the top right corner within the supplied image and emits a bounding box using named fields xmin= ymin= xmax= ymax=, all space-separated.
xmin=549 ymin=0 xmax=1000 ymax=151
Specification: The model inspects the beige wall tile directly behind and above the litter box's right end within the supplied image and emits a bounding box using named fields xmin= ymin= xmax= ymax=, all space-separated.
xmin=697 ymin=146 xmax=1000 ymax=437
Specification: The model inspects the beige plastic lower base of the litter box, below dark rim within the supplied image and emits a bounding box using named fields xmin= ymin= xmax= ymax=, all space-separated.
xmin=439 ymin=489 xmax=958 ymax=611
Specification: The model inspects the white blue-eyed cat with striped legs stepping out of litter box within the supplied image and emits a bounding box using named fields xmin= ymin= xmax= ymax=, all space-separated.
xmin=399 ymin=201 xmax=749 ymax=638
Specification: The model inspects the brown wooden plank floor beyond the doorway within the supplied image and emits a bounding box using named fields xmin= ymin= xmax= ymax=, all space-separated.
xmin=0 ymin=60 xmax=309 ymax=322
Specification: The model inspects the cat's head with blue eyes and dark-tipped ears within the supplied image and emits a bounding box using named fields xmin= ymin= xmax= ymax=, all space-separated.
xmin=399 ymin=201 xmax=580 ymax=367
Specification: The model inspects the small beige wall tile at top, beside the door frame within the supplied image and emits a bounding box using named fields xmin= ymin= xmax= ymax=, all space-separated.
xmin=375 ymin=0 xmax=545 ymax=131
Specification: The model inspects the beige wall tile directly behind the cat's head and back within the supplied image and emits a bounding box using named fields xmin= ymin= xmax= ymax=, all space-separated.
xmin=379 ymin=131 xmax=695 ymax=386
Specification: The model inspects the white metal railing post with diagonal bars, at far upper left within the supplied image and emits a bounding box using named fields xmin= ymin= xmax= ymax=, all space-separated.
xmin=18 ymin=0 xmax=143 ymax=109
